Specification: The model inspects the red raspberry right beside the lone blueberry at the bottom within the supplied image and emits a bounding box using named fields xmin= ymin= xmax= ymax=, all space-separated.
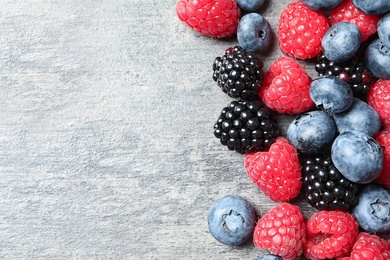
xmin=253 ymin=202 xmax=306 ymax=260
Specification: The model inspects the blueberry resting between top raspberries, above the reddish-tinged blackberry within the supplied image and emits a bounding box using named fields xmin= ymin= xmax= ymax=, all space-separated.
xmin=321 ymin=22 xmax=361 ymax=63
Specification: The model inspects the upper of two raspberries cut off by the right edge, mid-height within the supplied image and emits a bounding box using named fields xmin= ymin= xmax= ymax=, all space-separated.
xmin=367 ymin=79 xmax=390 ymax=128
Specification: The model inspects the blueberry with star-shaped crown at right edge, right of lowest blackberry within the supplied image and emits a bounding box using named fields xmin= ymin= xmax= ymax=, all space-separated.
xmin=352 ymin=183 xmax=390 ymax=233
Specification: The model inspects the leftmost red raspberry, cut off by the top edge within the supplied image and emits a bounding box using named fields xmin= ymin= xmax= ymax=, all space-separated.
xmin=176 ymin=0 xmax=241 ymax=38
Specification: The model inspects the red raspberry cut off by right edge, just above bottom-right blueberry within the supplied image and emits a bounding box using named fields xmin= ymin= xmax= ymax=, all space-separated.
xmin=375 ymin=129 xmax=390 ymax=188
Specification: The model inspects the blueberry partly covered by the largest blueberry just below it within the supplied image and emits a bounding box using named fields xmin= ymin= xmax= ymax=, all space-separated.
xmin=333 ymin=98 xmax=381 ymax=137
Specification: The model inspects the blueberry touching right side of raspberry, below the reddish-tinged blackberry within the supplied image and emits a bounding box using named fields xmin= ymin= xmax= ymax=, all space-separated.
xmin=310 ymin=76 xmax=353 ymax=115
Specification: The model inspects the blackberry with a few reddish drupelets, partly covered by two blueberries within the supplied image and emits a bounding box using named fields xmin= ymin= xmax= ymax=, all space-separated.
xmin=315 ymin=54 xmax=375 ymax=97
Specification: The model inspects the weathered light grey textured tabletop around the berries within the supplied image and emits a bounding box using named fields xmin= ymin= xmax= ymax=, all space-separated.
xmin=0 ymin=0 xmax=342 ymax=260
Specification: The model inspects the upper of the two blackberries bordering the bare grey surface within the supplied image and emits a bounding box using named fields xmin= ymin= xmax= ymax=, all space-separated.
xmin=213 ymin=46 xmax=264 ymax=100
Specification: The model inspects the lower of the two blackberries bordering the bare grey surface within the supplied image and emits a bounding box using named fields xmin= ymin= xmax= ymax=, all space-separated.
xmin=214 ymin=100 xmax=279 ymax=154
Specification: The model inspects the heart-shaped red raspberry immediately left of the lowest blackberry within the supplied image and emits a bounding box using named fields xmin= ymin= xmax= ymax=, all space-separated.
xmin=244 ymin=137 xmax=302 ymax=202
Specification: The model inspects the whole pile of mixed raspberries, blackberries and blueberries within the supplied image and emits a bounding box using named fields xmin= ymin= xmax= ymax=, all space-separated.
xmin=176 ymin=0 xmax=390 ymax=260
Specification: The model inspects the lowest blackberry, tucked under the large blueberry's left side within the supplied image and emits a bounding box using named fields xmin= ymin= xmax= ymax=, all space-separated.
xmin=302 ymin=155 xmax=359 ymax=211
